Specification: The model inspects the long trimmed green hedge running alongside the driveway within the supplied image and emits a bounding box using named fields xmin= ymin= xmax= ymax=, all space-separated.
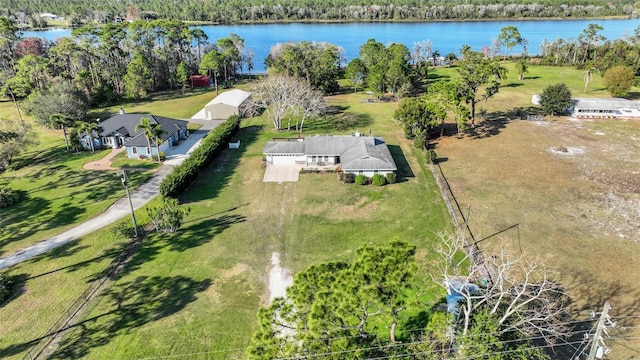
xmin=160 ymin=116 xmax=240 ymax=197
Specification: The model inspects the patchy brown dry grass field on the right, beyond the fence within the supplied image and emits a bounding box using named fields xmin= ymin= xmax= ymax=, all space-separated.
xmin=436 ymin=117 xmax=640 ymax=359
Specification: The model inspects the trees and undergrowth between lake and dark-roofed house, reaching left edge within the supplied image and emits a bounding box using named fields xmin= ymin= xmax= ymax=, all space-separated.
xmin=0 ymin=17 xmax=253 ymax=170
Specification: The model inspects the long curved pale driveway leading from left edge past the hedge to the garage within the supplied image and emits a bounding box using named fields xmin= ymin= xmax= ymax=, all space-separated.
xmin=0 ymin=119 xmax=223 ymax=269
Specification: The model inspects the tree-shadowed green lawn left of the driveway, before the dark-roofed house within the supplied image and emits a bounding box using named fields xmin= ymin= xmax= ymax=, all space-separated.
xmin=0 ymin=129 xmax=151 ymax=255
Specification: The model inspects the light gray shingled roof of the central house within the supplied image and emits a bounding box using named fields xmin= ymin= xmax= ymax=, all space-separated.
xmin=263 ymin=136 xmax=397 ymax=171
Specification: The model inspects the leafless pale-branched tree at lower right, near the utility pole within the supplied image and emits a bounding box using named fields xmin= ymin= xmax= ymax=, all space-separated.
xmin=436 ymin=235 xmax=568 ymax=344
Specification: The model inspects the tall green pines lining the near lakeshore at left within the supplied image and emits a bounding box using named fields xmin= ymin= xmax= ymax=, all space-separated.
xmin=0 ymin=17 xmax=253 ymax=109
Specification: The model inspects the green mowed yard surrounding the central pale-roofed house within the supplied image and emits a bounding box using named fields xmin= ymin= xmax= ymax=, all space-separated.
xmin=0 ymin=91 xmax=451 ymax=359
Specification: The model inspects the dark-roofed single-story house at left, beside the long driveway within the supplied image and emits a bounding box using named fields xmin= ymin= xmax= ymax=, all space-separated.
xmin=81 ymin=111 xmax=189 ymax=158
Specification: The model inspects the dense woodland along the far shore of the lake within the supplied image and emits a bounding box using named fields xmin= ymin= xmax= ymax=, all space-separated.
xmin=0 ymin=0 xmax=640 ymax=25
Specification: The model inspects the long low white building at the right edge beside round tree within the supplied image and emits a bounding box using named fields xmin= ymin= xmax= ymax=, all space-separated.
xmin=572 ymin=98 xmax=640 ymax=119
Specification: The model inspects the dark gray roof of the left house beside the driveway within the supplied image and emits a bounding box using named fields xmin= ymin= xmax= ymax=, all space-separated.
xmin=98 ymin=114 xmax=188 ymax=146
